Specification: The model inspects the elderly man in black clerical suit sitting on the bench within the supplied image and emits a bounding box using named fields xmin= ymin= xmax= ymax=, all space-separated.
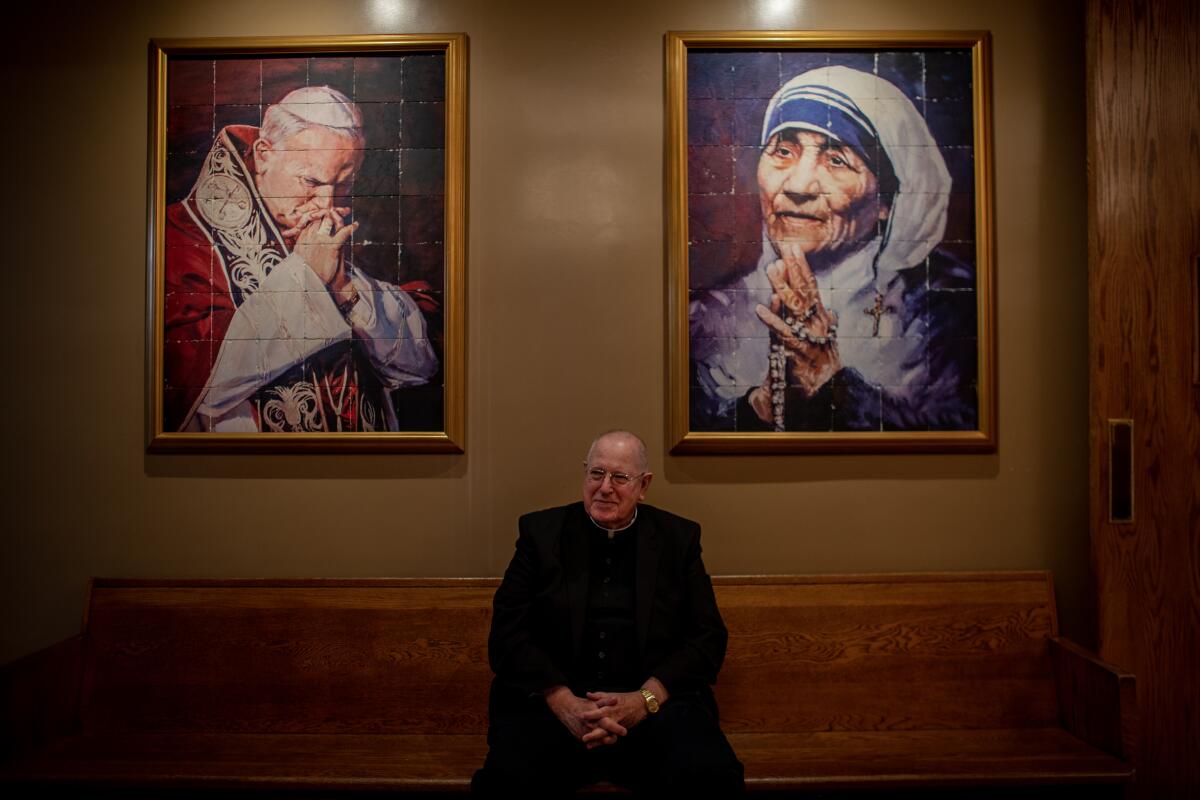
xmin=473 ymin=431 xmax=743 ymax=796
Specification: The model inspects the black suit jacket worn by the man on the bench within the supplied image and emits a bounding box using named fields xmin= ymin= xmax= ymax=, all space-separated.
xmin=487 ymin=503 xmax=728 ymax=709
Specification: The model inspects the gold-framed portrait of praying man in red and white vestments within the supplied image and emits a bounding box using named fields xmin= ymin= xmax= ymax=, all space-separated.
xmin=146 ymin=34 xmax=467 ymax=452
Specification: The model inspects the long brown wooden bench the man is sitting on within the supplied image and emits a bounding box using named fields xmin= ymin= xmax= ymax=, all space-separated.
xmin=0 ymin=572 xmax=1134 ymax=796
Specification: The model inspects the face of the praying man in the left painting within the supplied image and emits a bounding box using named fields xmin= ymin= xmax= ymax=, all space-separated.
xmin=254 ymin=126 xmax=362 ymax=228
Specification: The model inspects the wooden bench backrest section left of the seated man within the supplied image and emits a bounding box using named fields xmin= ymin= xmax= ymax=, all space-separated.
xmin=82 ymin=579 xmax=498 ymax=733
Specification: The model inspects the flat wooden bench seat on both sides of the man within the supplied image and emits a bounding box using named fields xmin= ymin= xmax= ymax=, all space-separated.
xmin=2 ymin=728 xmax=1130 ymax=790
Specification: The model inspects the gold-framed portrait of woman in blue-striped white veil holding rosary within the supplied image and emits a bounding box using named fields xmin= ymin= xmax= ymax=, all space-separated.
xmin=666 ymin=31 xmax=996 ymax=452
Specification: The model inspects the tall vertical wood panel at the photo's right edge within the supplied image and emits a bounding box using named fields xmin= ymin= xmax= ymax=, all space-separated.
xmin=1086 ymin=0 xmax=1200 ymax=798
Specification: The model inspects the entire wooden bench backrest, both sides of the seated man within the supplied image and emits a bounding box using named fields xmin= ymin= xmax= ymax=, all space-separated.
xmin=82 ymin=572 xmax=1057 ymax=734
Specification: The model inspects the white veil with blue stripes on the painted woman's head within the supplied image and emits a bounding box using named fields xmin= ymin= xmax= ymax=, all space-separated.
xmin=762 ymin=66 xmax=950 ymax=276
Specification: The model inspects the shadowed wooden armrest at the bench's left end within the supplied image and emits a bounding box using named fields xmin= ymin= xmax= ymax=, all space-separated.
xmin=0 ymin=636 xmax=83 ymax=758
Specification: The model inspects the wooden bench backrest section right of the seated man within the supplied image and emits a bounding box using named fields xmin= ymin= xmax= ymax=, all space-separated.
xmin=716 ymin=572 xmax=1058 ymax=732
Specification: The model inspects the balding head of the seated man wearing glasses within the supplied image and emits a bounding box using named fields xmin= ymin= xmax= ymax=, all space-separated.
xmin=583 ymin=434 xmax=652 ymax=528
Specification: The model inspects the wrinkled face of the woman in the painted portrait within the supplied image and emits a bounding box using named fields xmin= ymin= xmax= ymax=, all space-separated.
xmin=758 ymin=128 xmax=888 ymax=267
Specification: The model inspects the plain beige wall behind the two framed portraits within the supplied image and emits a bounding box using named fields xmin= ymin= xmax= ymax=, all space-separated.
xmin=0 ymin=0 xmax=1088 ymax=662
